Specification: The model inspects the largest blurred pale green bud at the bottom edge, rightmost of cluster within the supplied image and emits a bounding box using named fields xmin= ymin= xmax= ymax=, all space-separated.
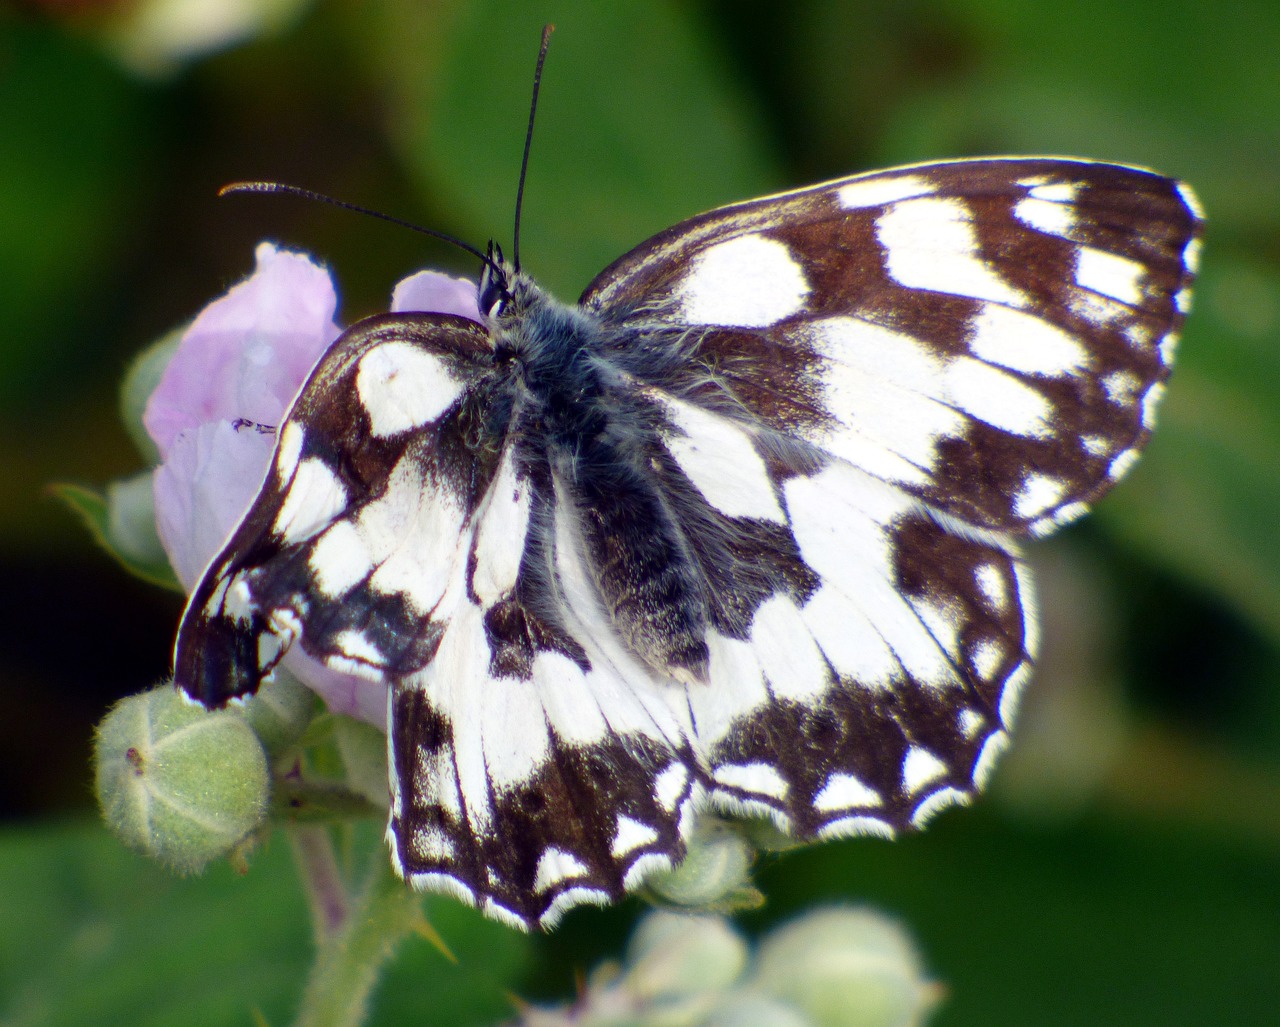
xmin=755 ymin=908 xmax=937 ymax=1027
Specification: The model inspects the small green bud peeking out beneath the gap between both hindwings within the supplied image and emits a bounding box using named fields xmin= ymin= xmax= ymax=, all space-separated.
xmin=645 ymin=818 xmax=760 ymax=912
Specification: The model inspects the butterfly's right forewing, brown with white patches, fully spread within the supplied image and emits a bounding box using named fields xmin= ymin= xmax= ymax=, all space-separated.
xmin=581 ymin=159 xmax=1199 ymax=533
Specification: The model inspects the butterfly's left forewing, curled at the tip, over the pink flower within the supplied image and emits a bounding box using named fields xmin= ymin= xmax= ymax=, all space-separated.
xmin=174 ymin=316 xmax=495 ymax=706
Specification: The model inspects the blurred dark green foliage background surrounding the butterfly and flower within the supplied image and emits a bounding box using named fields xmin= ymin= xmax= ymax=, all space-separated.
xmin=0 ymin=0 xmax=1280 ymax=1024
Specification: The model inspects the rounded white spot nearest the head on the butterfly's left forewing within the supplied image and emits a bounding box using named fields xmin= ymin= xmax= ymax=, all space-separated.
xmin=356 ymin=342 xmax=462 ymax=438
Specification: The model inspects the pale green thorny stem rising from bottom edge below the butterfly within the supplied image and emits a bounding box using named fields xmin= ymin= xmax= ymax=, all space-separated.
xmin=294 ymin=852 xmax=422 ymax=1027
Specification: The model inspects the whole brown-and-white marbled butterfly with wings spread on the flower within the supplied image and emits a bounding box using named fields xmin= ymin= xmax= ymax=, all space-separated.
xmin=175 ymin=158 xmax=1202 ymax=927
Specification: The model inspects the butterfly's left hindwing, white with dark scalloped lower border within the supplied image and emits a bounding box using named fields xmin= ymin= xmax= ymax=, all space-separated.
xmin=389 ymin=443 xmax=698 ymax=926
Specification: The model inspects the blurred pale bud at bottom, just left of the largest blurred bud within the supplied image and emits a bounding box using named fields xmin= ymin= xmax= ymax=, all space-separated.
xmin=622 ymin=909 xmax=748 ymax=1000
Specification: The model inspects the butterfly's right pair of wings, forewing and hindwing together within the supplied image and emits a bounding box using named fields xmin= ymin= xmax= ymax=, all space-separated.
xmin=581 ymin=159 xmax=1199 ymax=836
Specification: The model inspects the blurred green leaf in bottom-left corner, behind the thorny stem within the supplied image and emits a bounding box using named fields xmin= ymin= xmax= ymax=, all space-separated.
xmin=0 ymin=823 xmax=531 ymax=1027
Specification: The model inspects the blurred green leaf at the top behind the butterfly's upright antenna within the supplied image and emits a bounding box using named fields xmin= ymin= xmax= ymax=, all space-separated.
xmin=384 ymin=0 xmax=778 ymax=300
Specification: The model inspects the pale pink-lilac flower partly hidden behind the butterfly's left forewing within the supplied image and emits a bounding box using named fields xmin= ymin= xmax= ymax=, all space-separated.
xmin=142 ymin=242 xmax=480 ymax=727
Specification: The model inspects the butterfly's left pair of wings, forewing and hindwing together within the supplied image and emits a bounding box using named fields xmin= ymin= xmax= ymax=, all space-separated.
xmin=175 ymin=308 xmax=698 ymax=926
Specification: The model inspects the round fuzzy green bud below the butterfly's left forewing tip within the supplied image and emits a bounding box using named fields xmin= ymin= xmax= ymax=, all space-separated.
xmin=93 ymin=685 xmax=270 ymax=873
